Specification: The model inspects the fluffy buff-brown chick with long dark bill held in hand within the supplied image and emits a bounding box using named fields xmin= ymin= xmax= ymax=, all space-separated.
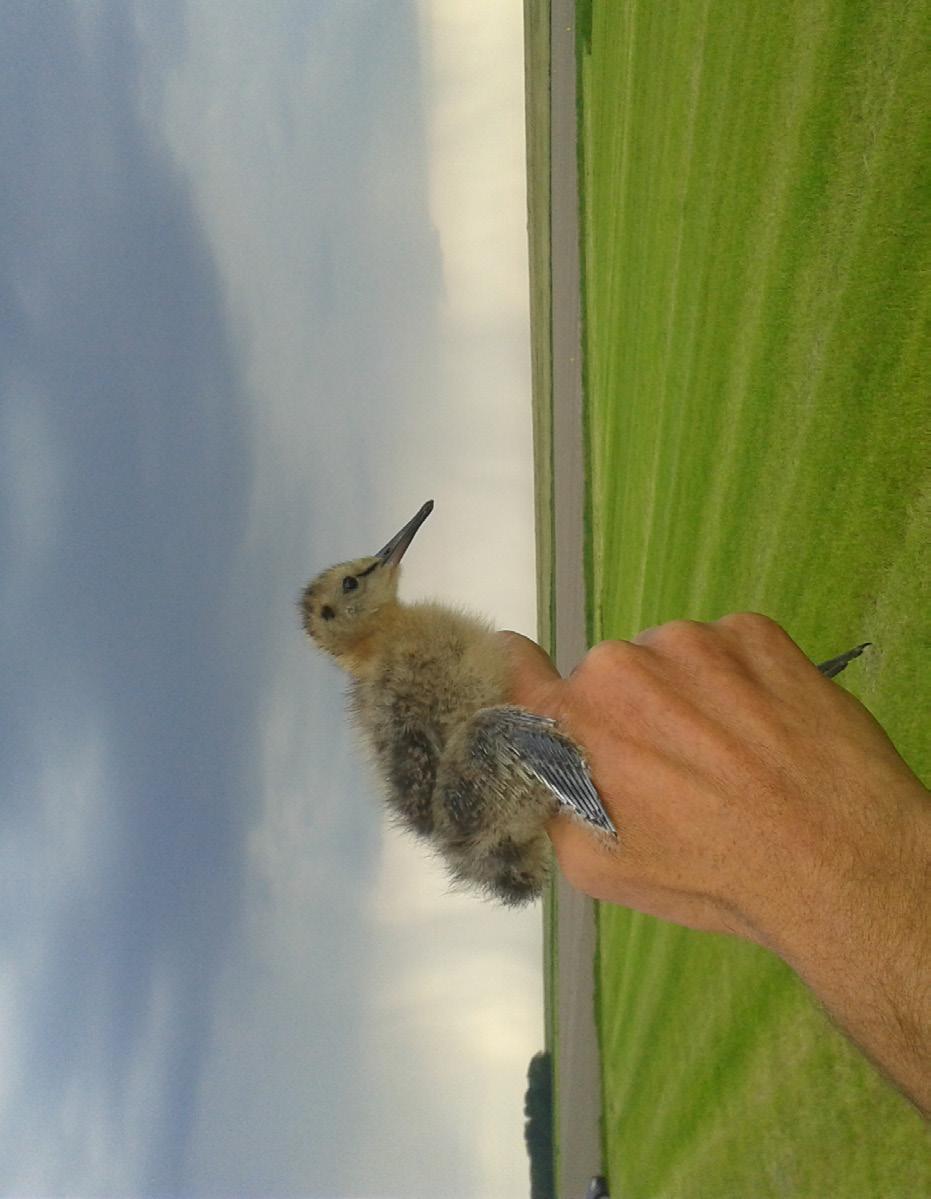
xmin=300 ymin=500 xmax=614 ymax=905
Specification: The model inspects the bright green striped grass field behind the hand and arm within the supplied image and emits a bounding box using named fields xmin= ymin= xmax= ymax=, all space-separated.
xmin=578 ymin=0 xmax=931 ymax=1199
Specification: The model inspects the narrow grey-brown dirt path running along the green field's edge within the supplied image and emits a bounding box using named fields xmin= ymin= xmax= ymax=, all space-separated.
xmin=549 ymin=0 xmax=601 ymax=1199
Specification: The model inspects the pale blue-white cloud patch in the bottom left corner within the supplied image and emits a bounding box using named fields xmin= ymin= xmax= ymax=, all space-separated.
xmin=0 ymin=713 xmax=137 ymax=1194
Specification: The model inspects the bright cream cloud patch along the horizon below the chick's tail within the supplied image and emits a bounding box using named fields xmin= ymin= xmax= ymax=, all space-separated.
xmin=366 ymin=833 xmax=543 ymax=1197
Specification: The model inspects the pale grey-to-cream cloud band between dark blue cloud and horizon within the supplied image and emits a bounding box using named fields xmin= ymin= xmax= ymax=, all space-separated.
xmin=127 ymin=0 xmax=542 ymax=1199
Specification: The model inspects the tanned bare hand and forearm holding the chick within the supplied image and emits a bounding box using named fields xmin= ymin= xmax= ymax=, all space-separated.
xmin=501 ymin=614 xmax=931 ymax=1119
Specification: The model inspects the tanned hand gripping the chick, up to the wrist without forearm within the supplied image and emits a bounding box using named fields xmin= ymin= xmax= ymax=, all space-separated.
xmin=505 ymin=614 xmax=927 ymax=952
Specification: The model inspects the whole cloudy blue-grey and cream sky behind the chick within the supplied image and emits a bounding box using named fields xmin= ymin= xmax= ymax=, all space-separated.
xmin=0 ymin=0 xmax=542 ymax=1199
